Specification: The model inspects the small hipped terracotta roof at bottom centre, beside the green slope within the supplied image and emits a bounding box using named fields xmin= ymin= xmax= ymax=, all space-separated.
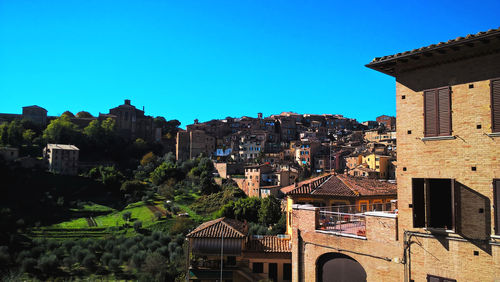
xmin=186 ymin=217 xmax=247 ymax=239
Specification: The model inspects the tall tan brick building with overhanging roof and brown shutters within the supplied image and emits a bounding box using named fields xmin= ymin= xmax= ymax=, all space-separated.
xmin=367 ymin=29 xmax=500 ymax=281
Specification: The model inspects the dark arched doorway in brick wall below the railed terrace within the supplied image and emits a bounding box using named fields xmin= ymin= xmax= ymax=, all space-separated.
xmin=316 ymin=253 xmax=366 ymax=282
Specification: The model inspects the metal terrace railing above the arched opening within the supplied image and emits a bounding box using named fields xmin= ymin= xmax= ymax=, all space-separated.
xmin=318 ymin=210 xmax=366 ymax=237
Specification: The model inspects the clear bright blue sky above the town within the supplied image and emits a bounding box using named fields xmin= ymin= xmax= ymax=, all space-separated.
xmin=0 ymin=0 xmax=500 ymax=127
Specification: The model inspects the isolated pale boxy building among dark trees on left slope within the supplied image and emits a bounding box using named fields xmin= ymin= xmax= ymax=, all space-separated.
xmin=43 ymin=144 xmax=80 ymax=175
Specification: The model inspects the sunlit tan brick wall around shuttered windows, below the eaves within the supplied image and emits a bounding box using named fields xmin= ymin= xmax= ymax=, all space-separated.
xmin=396 ymin=51 xmax=500 ymax=281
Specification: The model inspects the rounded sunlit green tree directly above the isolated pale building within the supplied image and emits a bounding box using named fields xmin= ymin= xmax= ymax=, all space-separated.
xmin=43 ymin=115 xmax=81 ymax=144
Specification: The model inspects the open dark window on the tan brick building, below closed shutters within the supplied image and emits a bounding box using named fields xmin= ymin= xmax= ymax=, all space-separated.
xmin=412 ymin=178 xmax=458 ymax=230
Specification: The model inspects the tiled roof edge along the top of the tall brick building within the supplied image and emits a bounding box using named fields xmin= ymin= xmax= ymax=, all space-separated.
xmin=367 ymin=27 xmax=500 ymax=66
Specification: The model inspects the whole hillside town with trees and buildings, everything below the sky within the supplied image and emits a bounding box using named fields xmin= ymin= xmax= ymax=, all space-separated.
xmin=0 ymin=8 xmax=500 ymax=282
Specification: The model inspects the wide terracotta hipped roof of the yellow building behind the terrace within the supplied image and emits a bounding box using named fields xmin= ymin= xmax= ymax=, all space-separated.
xmin=286 ymin=175 xmax=397 ymax=197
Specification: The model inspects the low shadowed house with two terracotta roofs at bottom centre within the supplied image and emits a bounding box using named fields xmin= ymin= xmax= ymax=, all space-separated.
xmin=186 ymin=218 xmax=292 ymax=282
